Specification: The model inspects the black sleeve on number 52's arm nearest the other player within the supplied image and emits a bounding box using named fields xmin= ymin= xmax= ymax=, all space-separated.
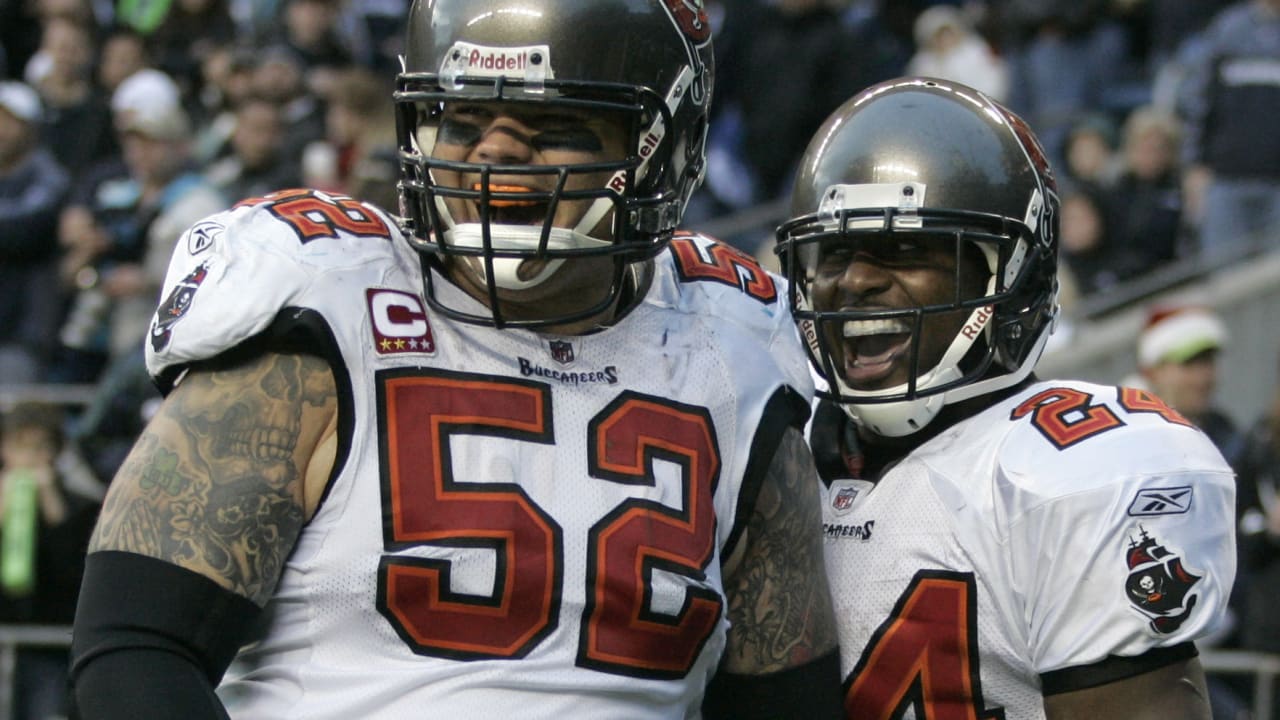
xmin=703 ymin=650 xmax=844 ymax=720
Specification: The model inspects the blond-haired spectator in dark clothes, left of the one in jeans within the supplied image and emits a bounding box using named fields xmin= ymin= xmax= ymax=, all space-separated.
xmin=1107 ymin=106 xmax=1183 ymax=270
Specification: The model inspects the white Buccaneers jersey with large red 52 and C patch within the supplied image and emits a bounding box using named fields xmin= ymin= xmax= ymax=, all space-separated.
xmin=147 ymin=191 xmax=813 ymax=720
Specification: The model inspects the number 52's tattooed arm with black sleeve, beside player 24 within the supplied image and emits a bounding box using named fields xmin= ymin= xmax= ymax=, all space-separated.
xmin=703 ymin=429 xmax=840 ymax=719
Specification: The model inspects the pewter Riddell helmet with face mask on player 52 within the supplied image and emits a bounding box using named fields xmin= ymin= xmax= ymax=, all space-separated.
xmin=396 ymin=0 xmax=712 ymax=325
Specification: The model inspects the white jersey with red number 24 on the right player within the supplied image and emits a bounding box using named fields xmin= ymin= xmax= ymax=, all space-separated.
xmin=823 ymin=380 xmax=1235 ymax=720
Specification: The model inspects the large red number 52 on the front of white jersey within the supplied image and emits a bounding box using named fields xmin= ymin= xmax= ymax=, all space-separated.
xmin=378 ymin=370 xmax=723 ymax=679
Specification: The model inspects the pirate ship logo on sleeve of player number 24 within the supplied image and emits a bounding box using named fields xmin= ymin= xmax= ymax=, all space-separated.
xmin=1125 ymin=527 xmax=1201 ymax=634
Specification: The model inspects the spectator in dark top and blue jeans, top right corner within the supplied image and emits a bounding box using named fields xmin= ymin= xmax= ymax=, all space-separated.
xmin=1180 ymin=0 xmax=1280 ymax=261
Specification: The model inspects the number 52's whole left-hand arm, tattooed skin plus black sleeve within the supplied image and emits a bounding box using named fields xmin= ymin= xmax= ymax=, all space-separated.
xmin=72 ymin=354 xmax=337 ymax=720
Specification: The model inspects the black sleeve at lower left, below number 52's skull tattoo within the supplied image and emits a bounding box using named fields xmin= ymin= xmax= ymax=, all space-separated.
xmin=72 ymin=551 xmax=260 ymax=720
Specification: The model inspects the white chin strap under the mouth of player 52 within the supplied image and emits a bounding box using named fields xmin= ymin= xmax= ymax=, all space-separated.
xmin=439 ymin=219 xmax=612 ymax=290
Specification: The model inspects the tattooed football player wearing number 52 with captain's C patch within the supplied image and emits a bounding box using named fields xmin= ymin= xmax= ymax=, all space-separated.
xmin=73 ymin=0 xmax=840 ymax=720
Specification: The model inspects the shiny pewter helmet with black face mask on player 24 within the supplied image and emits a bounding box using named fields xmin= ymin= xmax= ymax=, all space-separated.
xmin=778 ymin=78 xmax=1057 ymax=437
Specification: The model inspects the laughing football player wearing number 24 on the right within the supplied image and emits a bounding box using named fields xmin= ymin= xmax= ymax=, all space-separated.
xmin=778 ymin=78 xmax=1235 ymax=720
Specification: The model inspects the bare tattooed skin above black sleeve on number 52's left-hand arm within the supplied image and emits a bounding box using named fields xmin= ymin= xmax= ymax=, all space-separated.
xmin=90 ymin=355 xmax=337 ymax=606
